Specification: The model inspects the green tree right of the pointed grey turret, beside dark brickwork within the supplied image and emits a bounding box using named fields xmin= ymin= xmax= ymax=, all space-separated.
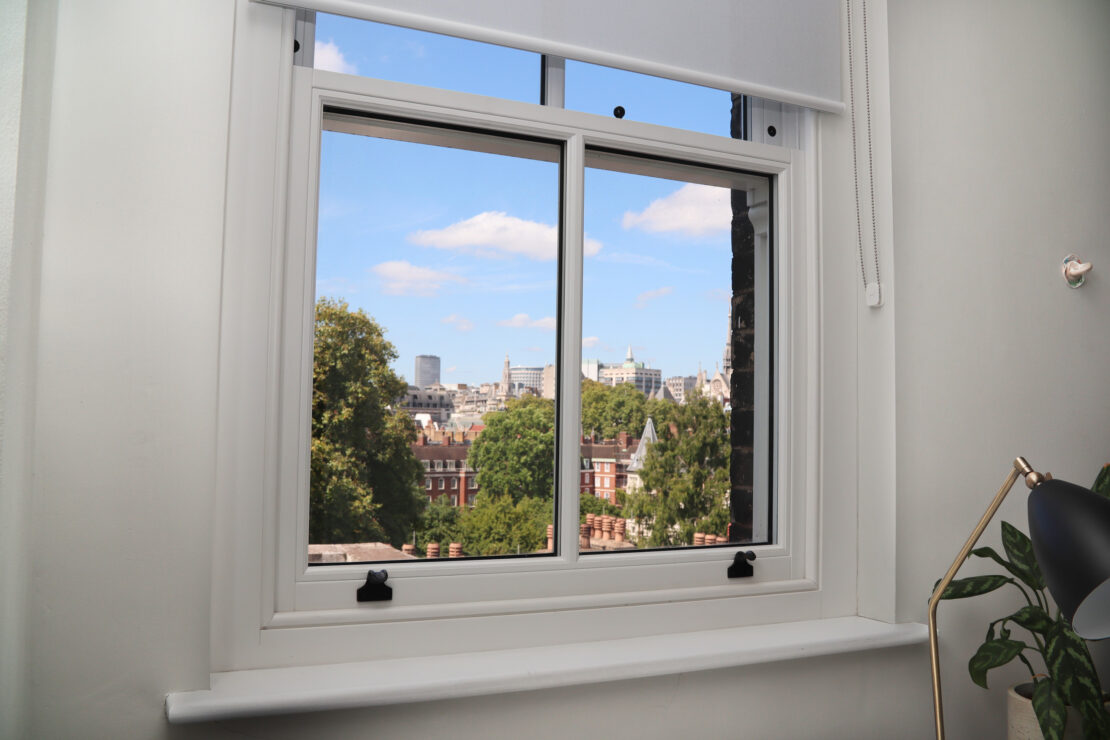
xmin=625 ymin=395 xmax=731 ymax=547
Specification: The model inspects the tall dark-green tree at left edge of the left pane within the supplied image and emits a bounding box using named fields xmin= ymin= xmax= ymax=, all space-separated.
xmin=309 ymin=298 xmax=424 ymax=547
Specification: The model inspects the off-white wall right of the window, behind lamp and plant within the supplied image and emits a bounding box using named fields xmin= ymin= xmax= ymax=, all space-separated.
xmin=889 ymin=0 xmax=1110 ymax=738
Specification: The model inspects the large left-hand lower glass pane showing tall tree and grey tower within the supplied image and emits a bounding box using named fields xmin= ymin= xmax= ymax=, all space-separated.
xmin=309 ymin=113 xmax=559 ymax=564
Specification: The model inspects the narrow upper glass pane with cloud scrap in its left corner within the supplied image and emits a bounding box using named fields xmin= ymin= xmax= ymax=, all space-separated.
xmin=313 ymin=13 xmax=539 ymax=103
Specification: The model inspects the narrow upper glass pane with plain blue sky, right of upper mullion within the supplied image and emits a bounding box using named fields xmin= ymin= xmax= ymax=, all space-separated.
xmin=565 ymin=59 xmax=733 ymax=136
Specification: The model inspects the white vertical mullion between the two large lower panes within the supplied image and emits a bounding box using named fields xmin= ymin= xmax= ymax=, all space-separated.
xmin=556 ymin=134 xmax=586 ymax=561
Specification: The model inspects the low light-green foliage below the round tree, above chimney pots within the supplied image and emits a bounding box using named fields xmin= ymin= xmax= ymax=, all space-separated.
xmin=460 ymin=490 xmax=555 ymax=556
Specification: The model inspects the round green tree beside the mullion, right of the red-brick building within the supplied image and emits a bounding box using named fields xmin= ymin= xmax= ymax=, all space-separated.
xmin=467 ymin=396 xmax=555 ymax=504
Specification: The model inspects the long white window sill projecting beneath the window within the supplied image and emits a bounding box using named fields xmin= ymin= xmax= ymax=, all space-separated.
xmin=165 ymin=617 xmax=928 ymax=723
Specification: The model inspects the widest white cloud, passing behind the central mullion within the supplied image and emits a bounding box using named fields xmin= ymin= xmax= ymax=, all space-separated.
xmin=408 ymin=211 xmax=602 ymax=260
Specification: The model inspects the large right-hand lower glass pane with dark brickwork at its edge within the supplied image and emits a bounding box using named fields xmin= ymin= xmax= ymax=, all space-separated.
xmin=579 ymin=152 xmax=769 ymax=553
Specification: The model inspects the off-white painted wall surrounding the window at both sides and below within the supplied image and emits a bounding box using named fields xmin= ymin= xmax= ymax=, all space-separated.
xmin=8 ymin=0 xmax=1110 ymax=740
